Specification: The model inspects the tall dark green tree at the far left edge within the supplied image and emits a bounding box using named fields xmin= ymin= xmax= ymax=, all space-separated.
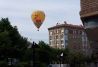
xmin=0 ymin=18 xmax=29 ymax=66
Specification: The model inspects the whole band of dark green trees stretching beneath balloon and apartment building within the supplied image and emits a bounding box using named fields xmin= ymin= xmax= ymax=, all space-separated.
xmin=0 ymin=18 xmax=92 ymax=67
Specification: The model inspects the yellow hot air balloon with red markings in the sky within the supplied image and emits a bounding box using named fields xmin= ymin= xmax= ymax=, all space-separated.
xmin=31 ymin=10 xmax=45 ymax=31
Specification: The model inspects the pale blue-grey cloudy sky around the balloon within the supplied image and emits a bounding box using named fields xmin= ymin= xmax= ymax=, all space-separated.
xmin=0 ymin=0 xmax=82 ymax=43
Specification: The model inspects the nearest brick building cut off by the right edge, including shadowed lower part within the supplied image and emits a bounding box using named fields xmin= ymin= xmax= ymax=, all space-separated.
xmin=80 ymin=0 xmax=98 ymax=56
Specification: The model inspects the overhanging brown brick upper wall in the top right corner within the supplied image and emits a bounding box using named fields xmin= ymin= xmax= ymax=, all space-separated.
xmin=80 ymin=0 xmax=98 ymax=17
